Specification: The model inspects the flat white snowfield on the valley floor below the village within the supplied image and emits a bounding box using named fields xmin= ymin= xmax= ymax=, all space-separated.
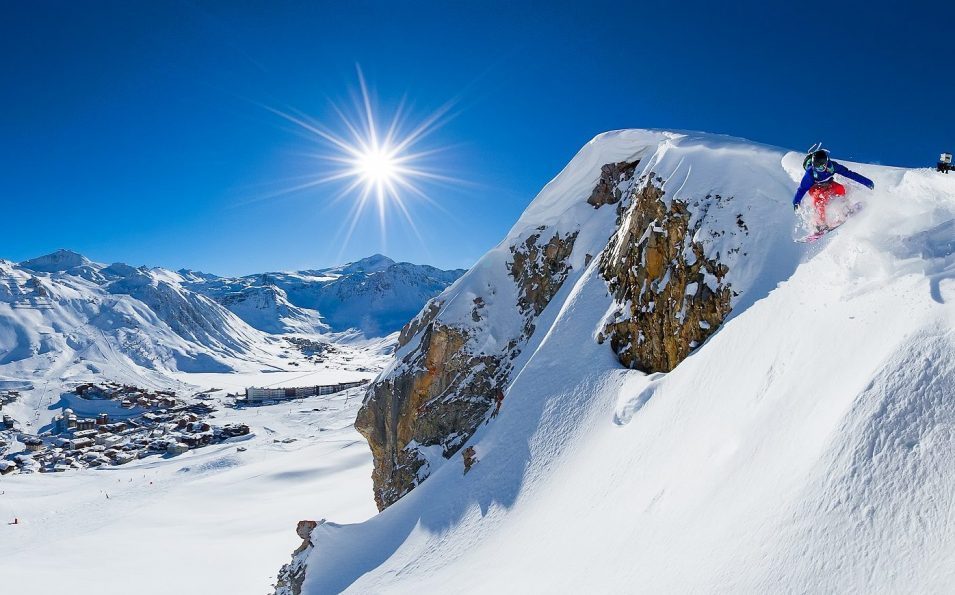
xmin=0 ymin=370 xmax=376 ymax=595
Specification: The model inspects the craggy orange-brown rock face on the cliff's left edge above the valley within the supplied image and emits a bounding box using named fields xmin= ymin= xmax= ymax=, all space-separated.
xmin=355 ymin=229 xmax=577 ymax=509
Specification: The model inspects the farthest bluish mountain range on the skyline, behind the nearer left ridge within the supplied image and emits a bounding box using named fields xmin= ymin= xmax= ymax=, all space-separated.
xmin=3 ymin=250 xmax=464 ymax=344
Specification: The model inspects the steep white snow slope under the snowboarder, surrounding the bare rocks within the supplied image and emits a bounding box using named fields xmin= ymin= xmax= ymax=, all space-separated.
xmin=296 ymin=131 xmax=955 ymax=594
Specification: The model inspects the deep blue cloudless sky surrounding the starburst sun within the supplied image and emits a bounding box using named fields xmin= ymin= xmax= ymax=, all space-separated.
xmin=0 ymin=0 xmax=955 ymax=274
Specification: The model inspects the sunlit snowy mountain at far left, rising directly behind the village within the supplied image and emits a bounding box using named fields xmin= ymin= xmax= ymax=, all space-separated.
xmin=0 ymin=250 xmax=268 ymax=377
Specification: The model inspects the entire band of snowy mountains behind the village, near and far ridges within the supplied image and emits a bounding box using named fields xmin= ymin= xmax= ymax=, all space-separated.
xmin=0 ymin=250 xmax=460 ymax=381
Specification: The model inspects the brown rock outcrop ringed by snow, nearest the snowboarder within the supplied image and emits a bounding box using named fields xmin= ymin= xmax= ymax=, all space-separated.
xmin=600 ymin=174 xmax=746 ymax=372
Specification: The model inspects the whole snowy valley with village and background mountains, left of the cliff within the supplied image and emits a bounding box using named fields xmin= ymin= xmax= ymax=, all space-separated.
xmin=0 ymin=250 xmax=461 ymax=594
